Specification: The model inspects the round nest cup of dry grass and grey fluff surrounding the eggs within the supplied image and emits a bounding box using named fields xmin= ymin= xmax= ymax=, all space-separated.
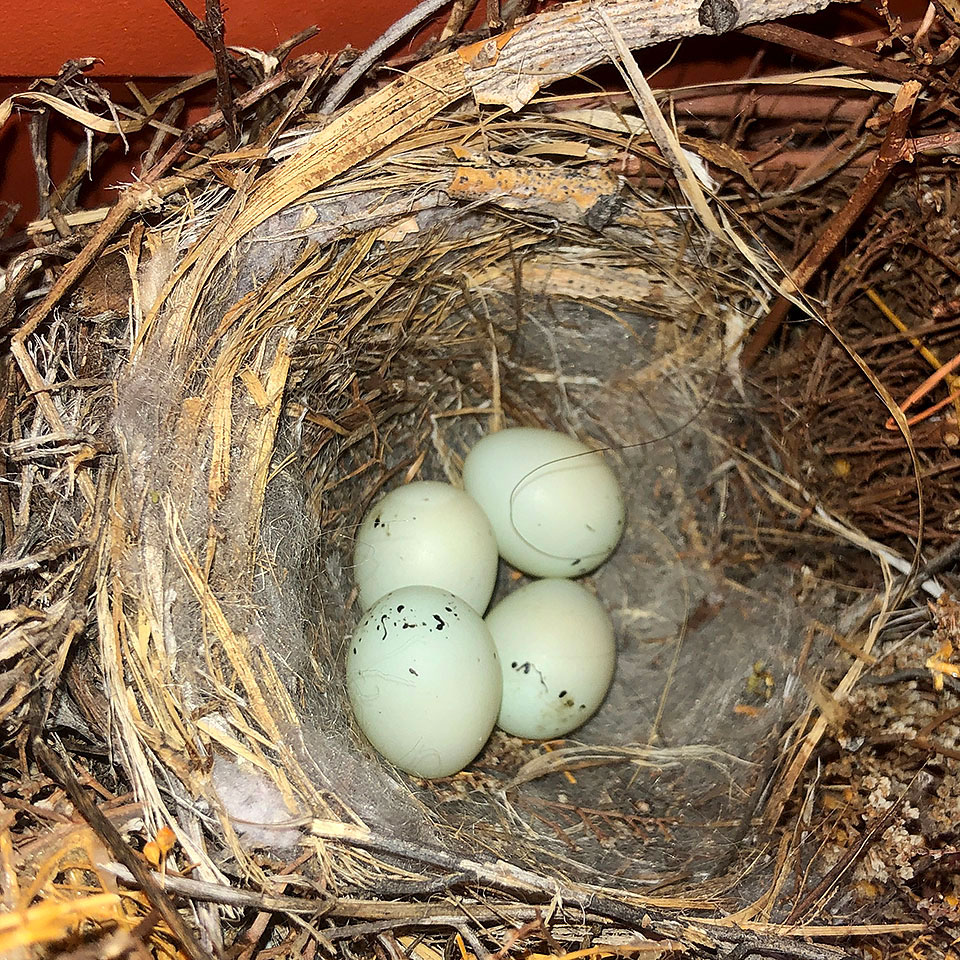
xmin=69 ymin=99 xmax=816 ymax=896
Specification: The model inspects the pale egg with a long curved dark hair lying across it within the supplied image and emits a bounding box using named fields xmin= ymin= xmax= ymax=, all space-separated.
xmin=463 ymin=427 xmax=626 ymax=577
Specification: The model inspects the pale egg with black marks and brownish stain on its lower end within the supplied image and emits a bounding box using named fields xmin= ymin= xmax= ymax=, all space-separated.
xmin=487 ymin=580 xmax=616 ymax=740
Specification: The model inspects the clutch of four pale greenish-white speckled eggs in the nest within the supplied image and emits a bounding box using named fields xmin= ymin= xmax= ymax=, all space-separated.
xmin=346 ymin=427 xmax=625 ymax=777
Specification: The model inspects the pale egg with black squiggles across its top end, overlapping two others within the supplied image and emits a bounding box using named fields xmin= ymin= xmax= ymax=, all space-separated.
xmin=346 ymin=586 xmax=502 ymax=777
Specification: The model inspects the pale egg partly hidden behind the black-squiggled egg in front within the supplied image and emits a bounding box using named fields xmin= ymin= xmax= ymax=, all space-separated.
xmin=353 ymin=480 xmax=498 ymax=616
